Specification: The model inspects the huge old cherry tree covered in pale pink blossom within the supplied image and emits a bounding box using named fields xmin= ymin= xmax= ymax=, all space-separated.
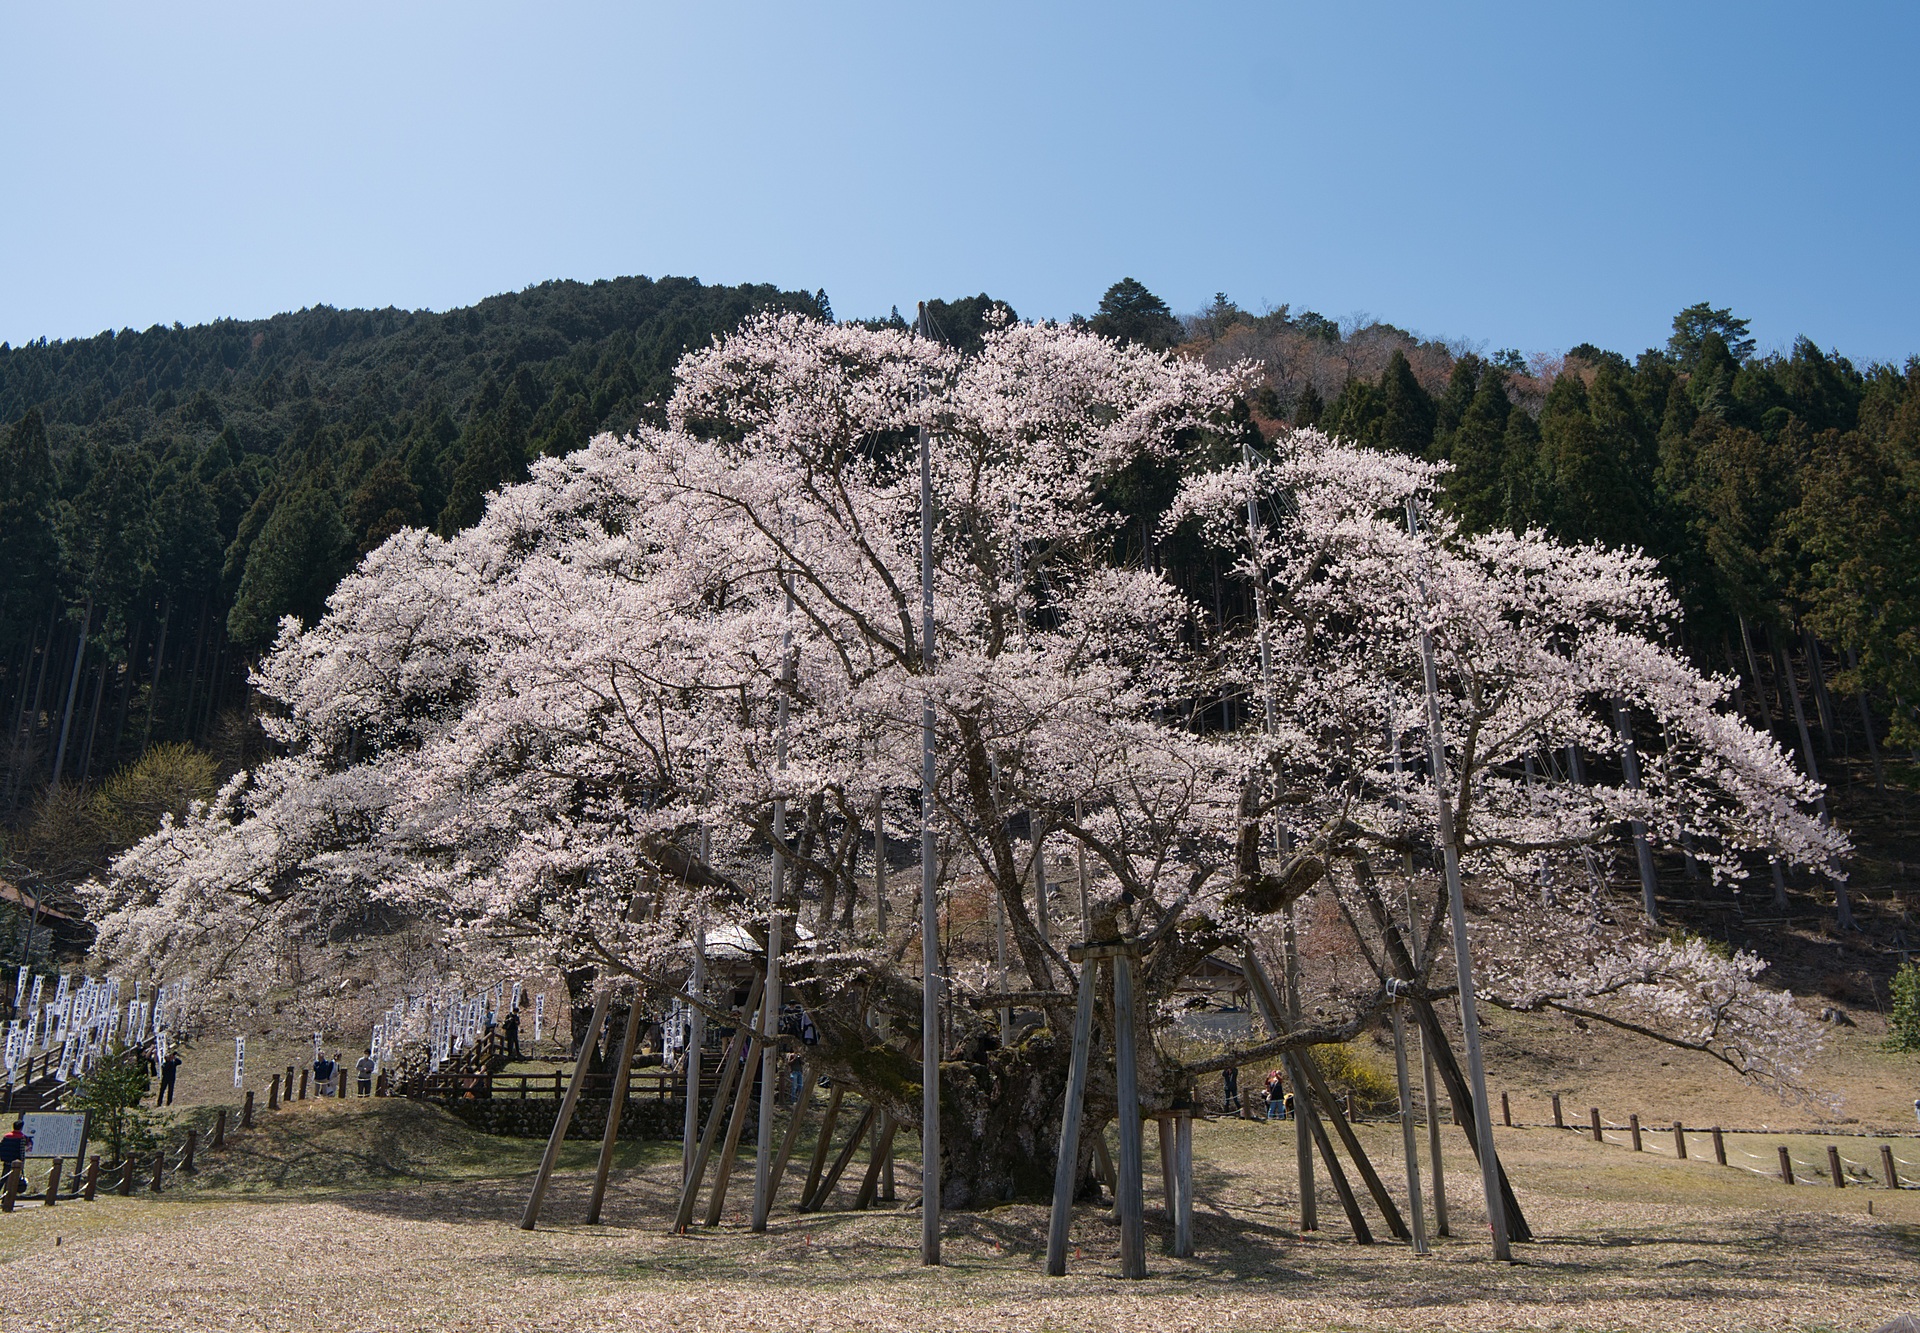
xmin=94 ymin=315 xmax=1845 ymax=1206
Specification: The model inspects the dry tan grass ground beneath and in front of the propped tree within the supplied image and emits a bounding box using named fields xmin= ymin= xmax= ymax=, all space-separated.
xmin=0 ymin=1075 xmax=1920 ymax=1333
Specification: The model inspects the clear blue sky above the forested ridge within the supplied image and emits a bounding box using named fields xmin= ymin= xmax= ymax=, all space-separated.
xmin=0 ymin=0 xmax=1920 ymax=361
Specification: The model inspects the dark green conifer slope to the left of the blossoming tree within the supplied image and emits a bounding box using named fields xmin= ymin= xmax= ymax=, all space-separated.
xmin=0 ymin=279 xmax=817 ymax=822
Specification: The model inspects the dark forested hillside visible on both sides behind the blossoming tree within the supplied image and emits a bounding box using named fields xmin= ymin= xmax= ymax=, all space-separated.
xmin=0 ymin=279 xmax=1920 ymax=945
